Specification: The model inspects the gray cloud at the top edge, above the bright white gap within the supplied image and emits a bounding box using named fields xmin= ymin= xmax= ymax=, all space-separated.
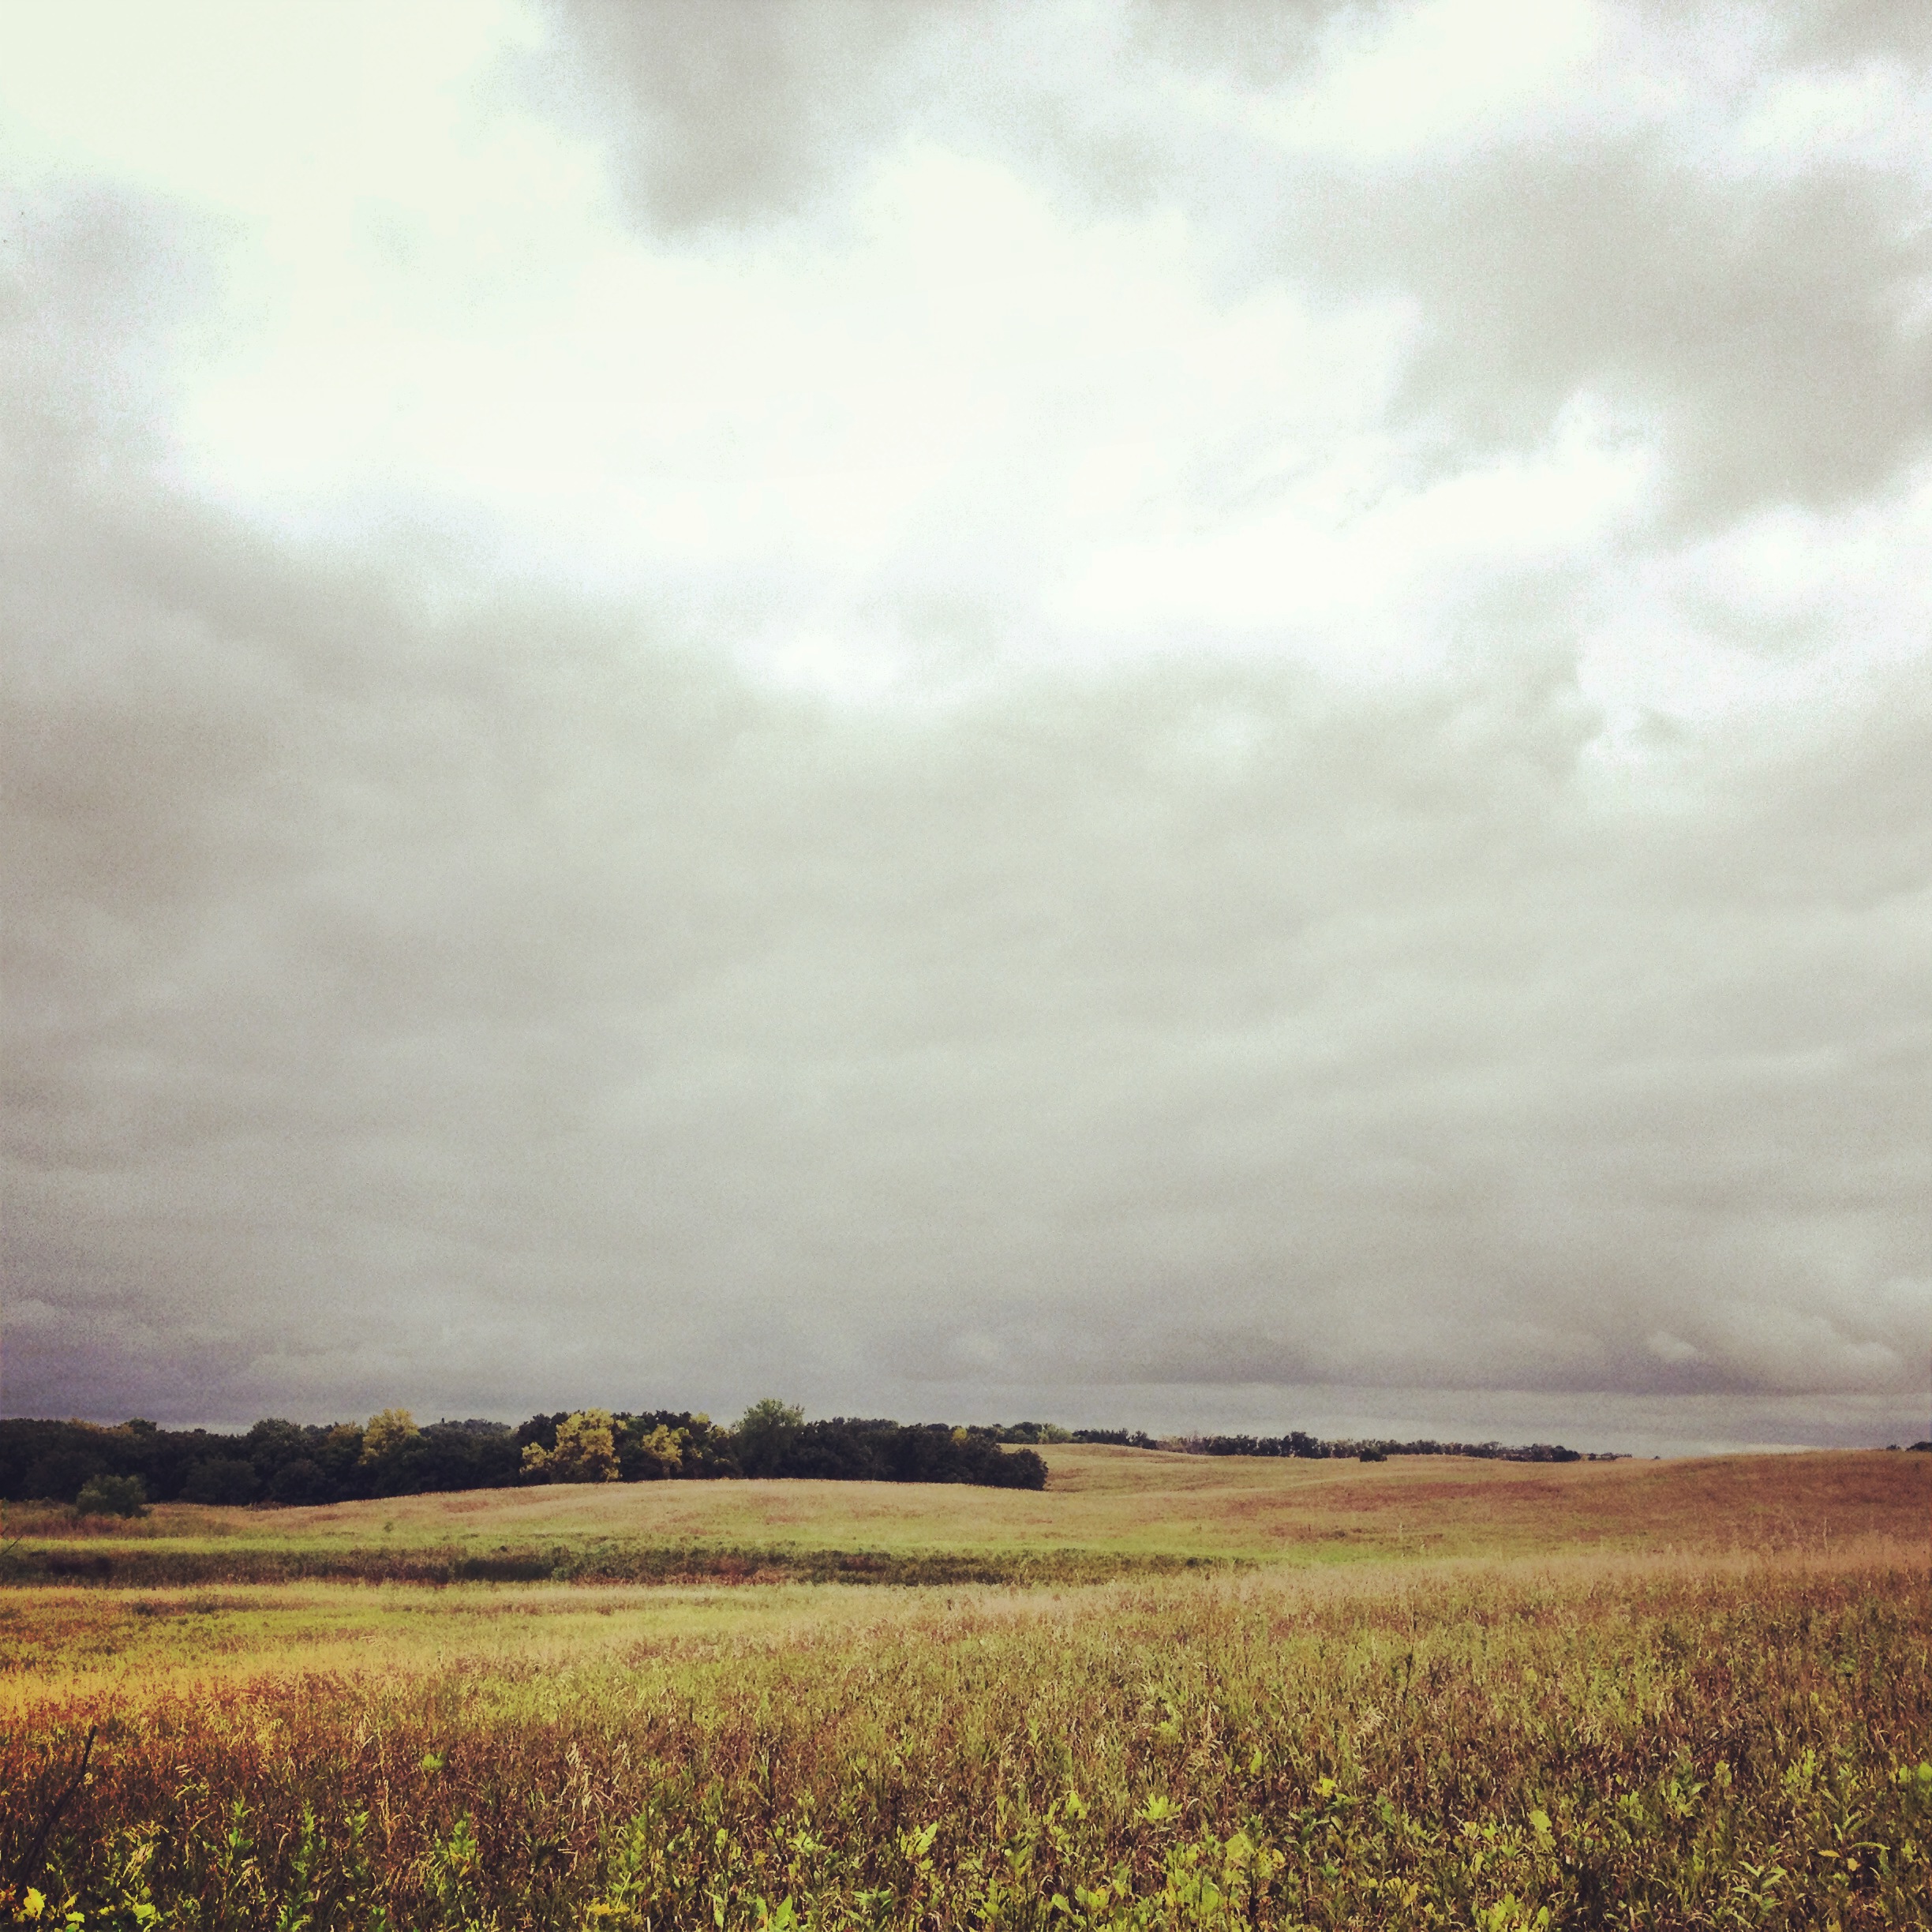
xmin=518 ymin=0 xmax=1344 ymax=236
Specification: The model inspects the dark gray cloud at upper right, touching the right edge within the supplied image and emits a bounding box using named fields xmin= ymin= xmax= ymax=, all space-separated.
xmin=1290 ymin=147 xmax=1932 ymax=520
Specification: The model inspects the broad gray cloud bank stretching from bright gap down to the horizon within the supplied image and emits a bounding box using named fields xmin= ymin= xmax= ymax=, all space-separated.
xmin=4 ymin=403 xmax=1932 ymax=1437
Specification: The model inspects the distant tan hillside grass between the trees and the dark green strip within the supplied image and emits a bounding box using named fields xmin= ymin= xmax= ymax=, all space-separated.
xmin=9 ymin=1445 xmax=1932 ymax=1563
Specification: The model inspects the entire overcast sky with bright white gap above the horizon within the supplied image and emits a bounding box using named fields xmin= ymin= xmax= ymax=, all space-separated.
xmin=0 ymin=0 xmax=1932 ymax=1453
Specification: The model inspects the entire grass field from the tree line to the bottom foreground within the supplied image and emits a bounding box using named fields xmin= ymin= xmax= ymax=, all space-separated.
xmin=0 ymin=1447 xmax=1932 ymax=1932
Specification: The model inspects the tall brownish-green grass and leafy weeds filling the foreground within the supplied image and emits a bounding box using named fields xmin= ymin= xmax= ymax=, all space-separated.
xmin=0 ymin=1561 xmax=1932 ymax=1932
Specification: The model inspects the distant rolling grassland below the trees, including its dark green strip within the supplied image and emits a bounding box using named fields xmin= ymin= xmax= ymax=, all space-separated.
xmin=6 ymin=1445 xmax=1932 ymax=1584
